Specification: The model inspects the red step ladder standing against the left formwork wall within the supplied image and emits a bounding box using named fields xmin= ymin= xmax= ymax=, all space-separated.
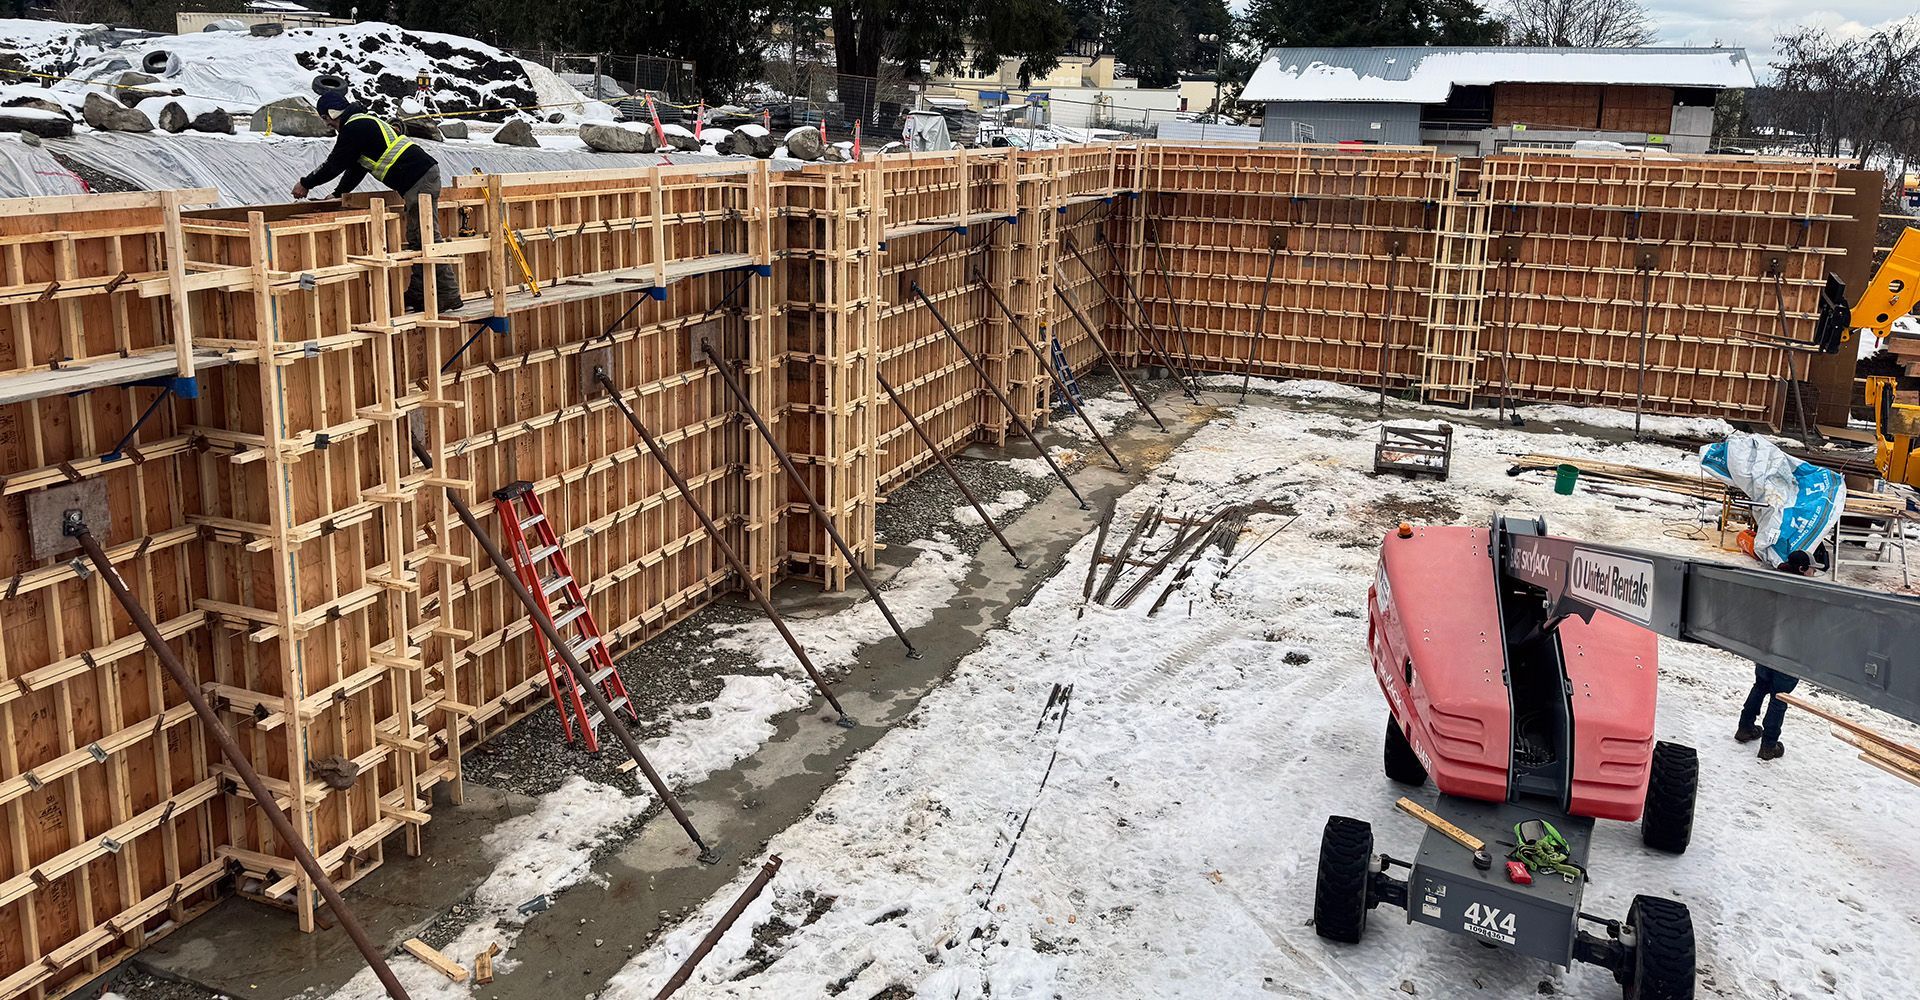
xmin=493 ymin=480 xmax=639 ymax=752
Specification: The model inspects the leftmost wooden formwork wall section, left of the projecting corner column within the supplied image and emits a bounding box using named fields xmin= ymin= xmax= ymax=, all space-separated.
xmin=0 ymin=192 xmax=222 ymax=998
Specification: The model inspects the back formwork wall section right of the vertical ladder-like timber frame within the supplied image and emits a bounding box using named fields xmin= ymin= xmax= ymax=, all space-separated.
xmin=1478 ymin=154 xmax=1851 ymax=424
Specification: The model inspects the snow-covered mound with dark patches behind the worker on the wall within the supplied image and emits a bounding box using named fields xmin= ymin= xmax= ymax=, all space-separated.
xmin=33 ymin=21 xmax=611 ymax=121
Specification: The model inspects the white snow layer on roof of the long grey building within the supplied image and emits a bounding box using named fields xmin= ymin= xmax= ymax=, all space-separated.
xmin=1240 ymin=46 xmax=1755 ymax=104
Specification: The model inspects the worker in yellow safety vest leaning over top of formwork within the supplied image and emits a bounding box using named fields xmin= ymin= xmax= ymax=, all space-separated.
xmin=294 ymin=90 xmax=461 ymax=313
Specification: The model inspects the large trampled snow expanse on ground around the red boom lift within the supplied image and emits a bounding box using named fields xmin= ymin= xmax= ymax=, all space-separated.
xmin=601 ymin=393 xmax=1920 ymax=1000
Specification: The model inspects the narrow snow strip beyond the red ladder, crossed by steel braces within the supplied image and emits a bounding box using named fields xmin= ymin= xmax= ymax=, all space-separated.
xmin=712 ymin=537 xmax=973 ymax=671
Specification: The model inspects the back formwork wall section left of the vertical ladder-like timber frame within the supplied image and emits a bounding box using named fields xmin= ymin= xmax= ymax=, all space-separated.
xmin=1139 ymin=146 xmax=1457 ymax=390
